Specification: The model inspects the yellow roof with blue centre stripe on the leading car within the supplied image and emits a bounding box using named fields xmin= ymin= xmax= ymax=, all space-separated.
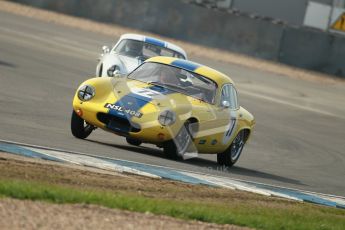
xmin=145 ymin=56 xmax=234 ymax=86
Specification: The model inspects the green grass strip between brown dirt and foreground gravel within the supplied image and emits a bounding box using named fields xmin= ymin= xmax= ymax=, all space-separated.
xmin=0 ymin=179 xmax=345 ymax=230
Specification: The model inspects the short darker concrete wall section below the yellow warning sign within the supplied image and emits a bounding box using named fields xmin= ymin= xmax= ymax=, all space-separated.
xmin=278 ymin=28 xmax=345 ymax=77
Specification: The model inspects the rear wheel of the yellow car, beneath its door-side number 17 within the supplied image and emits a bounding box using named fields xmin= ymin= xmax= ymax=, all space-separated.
xmin=217 ymin=130 xmax=245 ymax=166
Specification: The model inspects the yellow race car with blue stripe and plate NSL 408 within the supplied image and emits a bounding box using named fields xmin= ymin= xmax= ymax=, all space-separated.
xmin=71 ymin=57 xmax=255 ymax=166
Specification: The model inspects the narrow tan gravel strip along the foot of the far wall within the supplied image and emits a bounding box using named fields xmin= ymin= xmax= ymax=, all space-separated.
xmin=0 ymin=0 xmax=345 ymax=84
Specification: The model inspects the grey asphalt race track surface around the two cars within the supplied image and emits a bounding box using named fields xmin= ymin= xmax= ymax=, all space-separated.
xmin=0 ymin=11 xmax=345 ymax=196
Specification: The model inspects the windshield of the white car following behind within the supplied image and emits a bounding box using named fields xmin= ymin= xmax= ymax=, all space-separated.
xmin=114 ymin=39 xmax=185 ymax=60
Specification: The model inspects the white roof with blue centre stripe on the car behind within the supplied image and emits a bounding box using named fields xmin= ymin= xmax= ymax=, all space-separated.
xmin=120 ymin=34 xmax=187 ymax=59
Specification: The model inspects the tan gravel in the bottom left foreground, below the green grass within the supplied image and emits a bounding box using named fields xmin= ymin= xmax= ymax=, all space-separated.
xmin=0 ymin=198 xmax=248 ymax=230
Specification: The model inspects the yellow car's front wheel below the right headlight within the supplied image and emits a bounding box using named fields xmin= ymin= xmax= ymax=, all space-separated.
xmin=163 ymin=121 xmax=192 ymax=160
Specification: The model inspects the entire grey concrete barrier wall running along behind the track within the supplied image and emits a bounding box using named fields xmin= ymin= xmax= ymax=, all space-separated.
xmin=9 ymin=0 xmax=345 ymax=77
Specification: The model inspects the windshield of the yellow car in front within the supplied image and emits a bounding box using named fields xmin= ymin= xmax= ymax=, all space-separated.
xmin=128 ymin=62 xmax=217 ymax=104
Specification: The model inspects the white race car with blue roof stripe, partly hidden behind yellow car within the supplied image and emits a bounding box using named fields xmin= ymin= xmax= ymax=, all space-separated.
xmin=96 ymin=34 xmax=187 ymax=77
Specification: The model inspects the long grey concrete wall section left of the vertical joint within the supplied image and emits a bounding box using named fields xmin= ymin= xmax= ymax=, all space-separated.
xmin=10 ymin=0 xmax=283 ymax=60
